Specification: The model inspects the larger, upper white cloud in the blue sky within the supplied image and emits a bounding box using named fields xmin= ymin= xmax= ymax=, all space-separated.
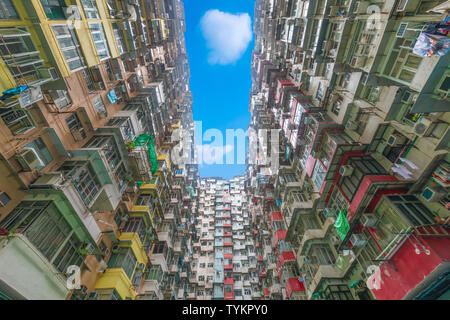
xmin=200 ymin=9 xmax=253 ymax=65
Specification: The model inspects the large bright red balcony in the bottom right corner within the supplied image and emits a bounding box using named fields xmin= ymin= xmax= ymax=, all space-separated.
xmin=368 ymin=224 xmax=450 ymax=300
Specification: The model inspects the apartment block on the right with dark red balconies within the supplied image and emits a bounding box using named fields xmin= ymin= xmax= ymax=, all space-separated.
xmin=245 ymin=0 xmax=450 ymax=300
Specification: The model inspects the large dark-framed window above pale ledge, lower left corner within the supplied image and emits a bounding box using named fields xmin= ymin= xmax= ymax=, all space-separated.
xmin=0 ymin=201 xmax=84 ymax=273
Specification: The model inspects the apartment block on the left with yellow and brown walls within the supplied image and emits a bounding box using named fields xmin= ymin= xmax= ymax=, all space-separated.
xmin=0 ymin=0 xmax=198 ymax=300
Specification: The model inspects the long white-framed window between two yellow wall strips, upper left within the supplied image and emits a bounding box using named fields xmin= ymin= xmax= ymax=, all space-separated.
xmin=52 ymin=25 xmax=85 ymax=71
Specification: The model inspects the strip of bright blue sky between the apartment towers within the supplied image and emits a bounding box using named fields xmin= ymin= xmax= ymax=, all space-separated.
xmin=184 ymin=0 xmax=254 ymax=178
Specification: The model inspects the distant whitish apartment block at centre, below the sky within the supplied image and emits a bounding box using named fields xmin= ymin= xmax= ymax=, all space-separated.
xmin=191 ymin=176 xmax=259 ymax=300
